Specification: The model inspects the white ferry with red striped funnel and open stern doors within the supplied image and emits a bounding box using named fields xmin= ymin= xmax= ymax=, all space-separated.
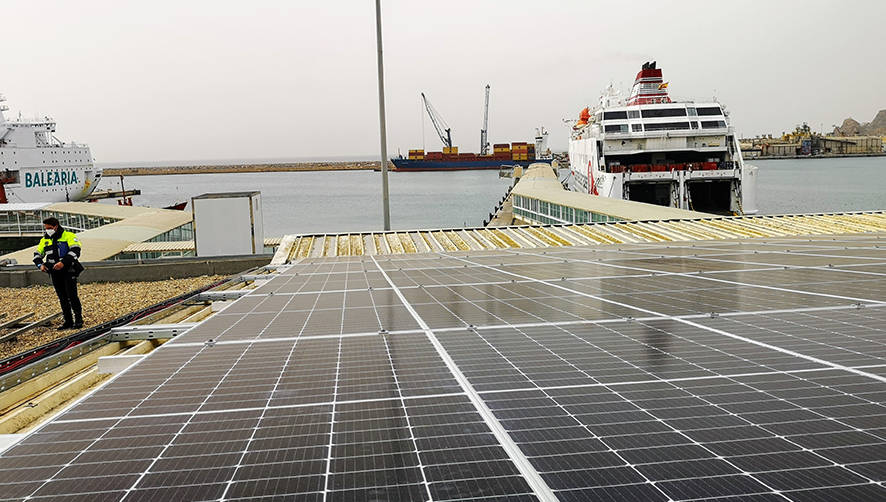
xmin=569 ymin=61 xmax=757 ymax=214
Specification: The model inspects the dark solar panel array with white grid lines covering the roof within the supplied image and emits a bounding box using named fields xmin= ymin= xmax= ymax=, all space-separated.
xmin=0 ymin=234 xmax=886 ymax=501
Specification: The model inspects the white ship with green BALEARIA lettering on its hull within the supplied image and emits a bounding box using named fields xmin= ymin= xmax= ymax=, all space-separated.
xmin=0 ymin=95 xmax=101 ymax=203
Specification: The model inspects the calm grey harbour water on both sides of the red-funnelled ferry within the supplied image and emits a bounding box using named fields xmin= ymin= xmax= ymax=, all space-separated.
xmin=100 ymin=157 xmax=886 ymax=236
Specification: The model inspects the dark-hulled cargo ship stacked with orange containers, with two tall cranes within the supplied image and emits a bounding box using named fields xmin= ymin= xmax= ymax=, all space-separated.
xmin=391 ymin=85 xmax=553 ymax=171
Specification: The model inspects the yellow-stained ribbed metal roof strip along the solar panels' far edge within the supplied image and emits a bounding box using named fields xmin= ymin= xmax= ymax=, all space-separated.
xmin=274 ymin=210 xmax=886 ymax=264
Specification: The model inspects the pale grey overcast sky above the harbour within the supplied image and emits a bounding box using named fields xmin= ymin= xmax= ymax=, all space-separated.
xmin=0 ymin=0 xmax=886 ymax=162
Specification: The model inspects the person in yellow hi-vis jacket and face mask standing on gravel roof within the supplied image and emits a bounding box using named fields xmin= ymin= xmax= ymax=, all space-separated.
xmin=34 ymin=217 xmax=83 ymax=331
